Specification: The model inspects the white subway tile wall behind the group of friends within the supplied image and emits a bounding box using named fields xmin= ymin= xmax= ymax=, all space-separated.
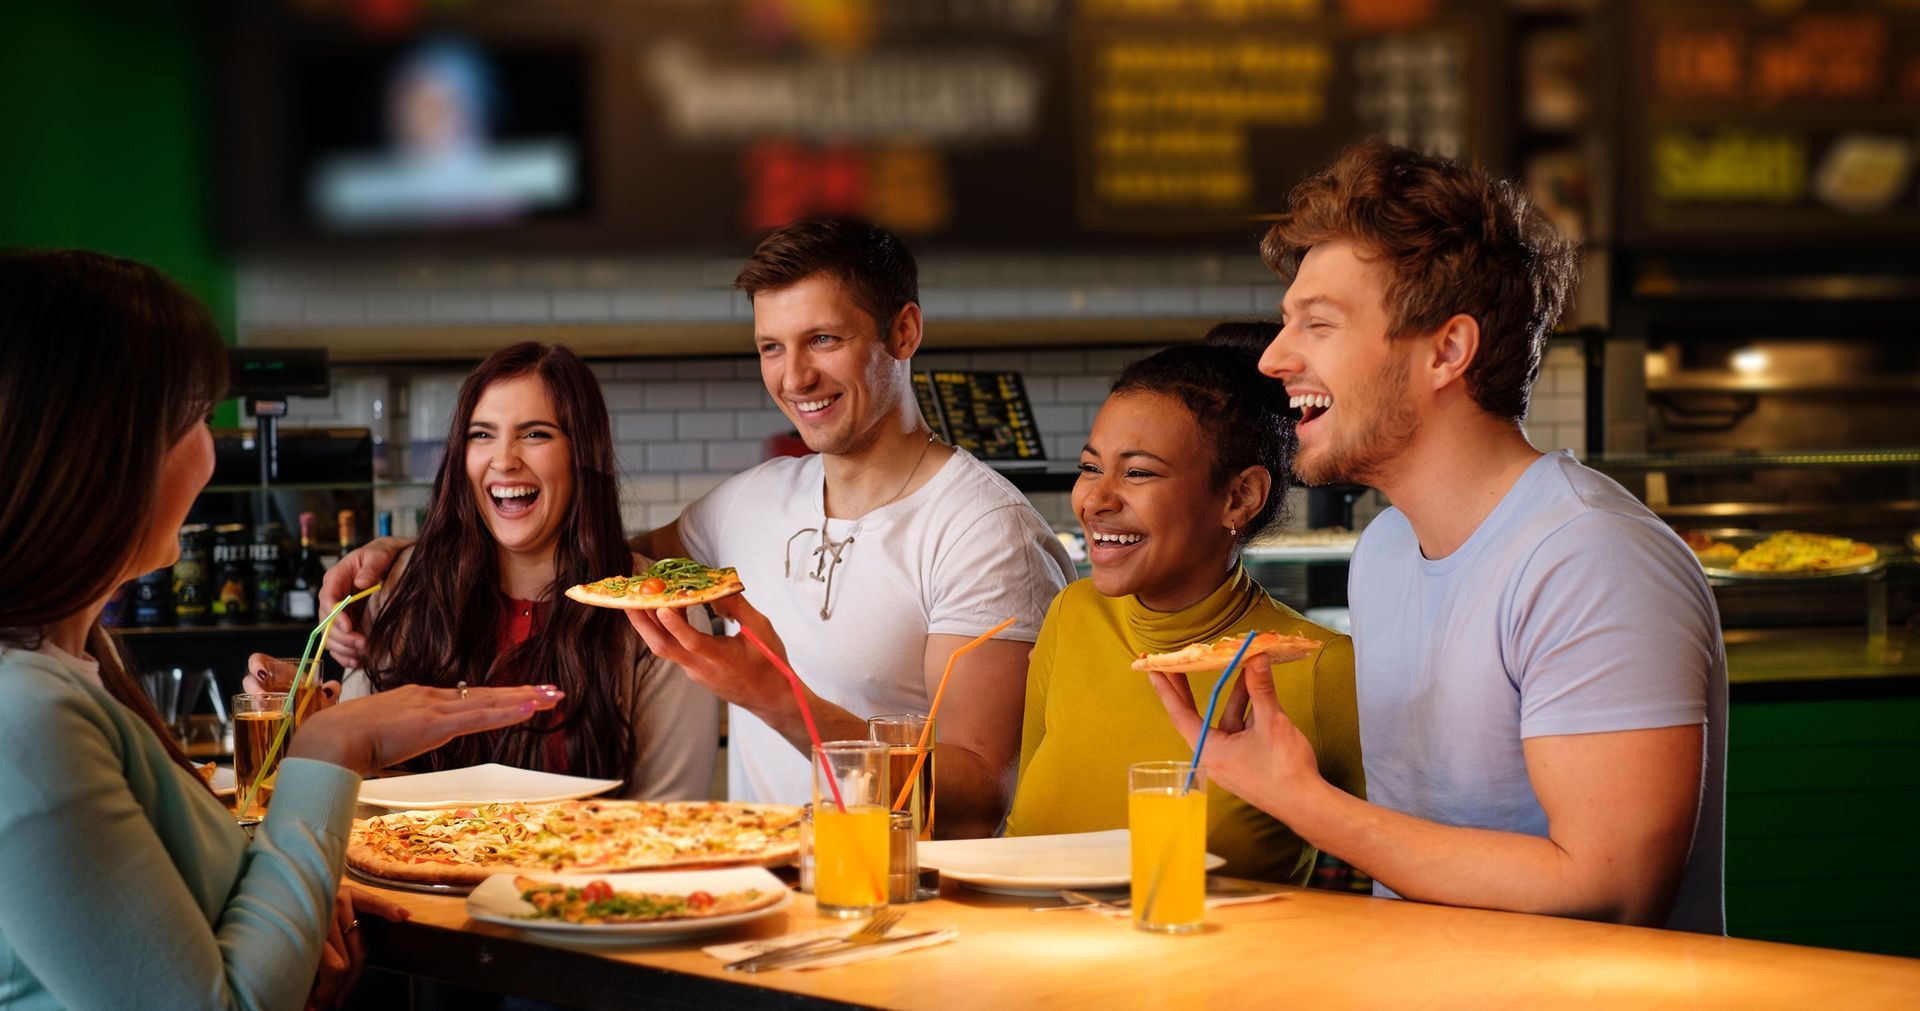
xmin=238 ymin=249 xmax=1586 ymax=531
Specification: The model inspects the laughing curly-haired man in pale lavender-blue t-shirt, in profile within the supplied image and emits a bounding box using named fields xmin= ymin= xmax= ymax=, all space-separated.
xmin=1154 ymin=142 xmax=1726 ymax=932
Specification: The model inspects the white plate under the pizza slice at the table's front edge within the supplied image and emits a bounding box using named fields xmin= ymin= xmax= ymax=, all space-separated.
xmin=467 ymin=867 xmax=793 ymax=944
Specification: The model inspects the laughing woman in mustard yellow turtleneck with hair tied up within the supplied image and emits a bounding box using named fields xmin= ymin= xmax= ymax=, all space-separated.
xmin=1006 ymin=324 xmax=1365 ymax=884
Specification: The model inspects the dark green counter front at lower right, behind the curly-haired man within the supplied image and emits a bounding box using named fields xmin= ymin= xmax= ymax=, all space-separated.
xmin=1726 ymin=698 xmax=1920 ymax=957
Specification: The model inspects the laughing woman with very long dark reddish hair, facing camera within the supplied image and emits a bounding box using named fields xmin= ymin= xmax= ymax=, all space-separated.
xmin=252 ymin=341 xmax=720 ymax=800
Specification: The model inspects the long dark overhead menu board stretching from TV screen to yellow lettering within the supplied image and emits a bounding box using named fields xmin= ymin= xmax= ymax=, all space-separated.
xmin=219 ymin=0 xmax=1503 ymax=249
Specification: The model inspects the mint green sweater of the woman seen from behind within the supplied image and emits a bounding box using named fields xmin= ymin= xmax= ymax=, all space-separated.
xmin=0 ymin=647 xmax=359 ymax=1009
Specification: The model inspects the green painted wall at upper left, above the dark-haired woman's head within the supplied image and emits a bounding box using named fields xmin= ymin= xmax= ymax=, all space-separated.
xmin=0 ymin=0 xmax=234 ymax=420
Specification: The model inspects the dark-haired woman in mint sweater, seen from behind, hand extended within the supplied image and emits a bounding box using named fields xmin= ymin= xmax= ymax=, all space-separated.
xmin=0 ymin=249 xmax=561 ymax=1009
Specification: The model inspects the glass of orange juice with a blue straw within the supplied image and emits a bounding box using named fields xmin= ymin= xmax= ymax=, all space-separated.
xmin=1127 ymin=760 xmax=1206 ymax=934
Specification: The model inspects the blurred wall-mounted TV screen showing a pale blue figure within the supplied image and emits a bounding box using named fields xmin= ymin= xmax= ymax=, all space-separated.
xmin=213 ymin=4 xmax=605 ymax=251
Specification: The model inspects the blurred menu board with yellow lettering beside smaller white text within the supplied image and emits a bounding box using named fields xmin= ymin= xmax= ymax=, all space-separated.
xmin=1071 ymin=0 xmax=1488 ymax=232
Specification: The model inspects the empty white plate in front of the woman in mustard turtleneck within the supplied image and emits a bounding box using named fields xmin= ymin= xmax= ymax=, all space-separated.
xmin=920 ymin=829 xmax=1227 ymax=896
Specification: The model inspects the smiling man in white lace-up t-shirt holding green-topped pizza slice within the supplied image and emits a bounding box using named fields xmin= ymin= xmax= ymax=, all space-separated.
xmin=628 ymin=219 xmax=1073 ymax=836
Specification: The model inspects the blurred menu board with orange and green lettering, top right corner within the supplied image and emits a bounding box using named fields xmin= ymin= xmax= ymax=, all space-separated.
xmin=1620 ymin=0 xmax=1920 ymax=246
